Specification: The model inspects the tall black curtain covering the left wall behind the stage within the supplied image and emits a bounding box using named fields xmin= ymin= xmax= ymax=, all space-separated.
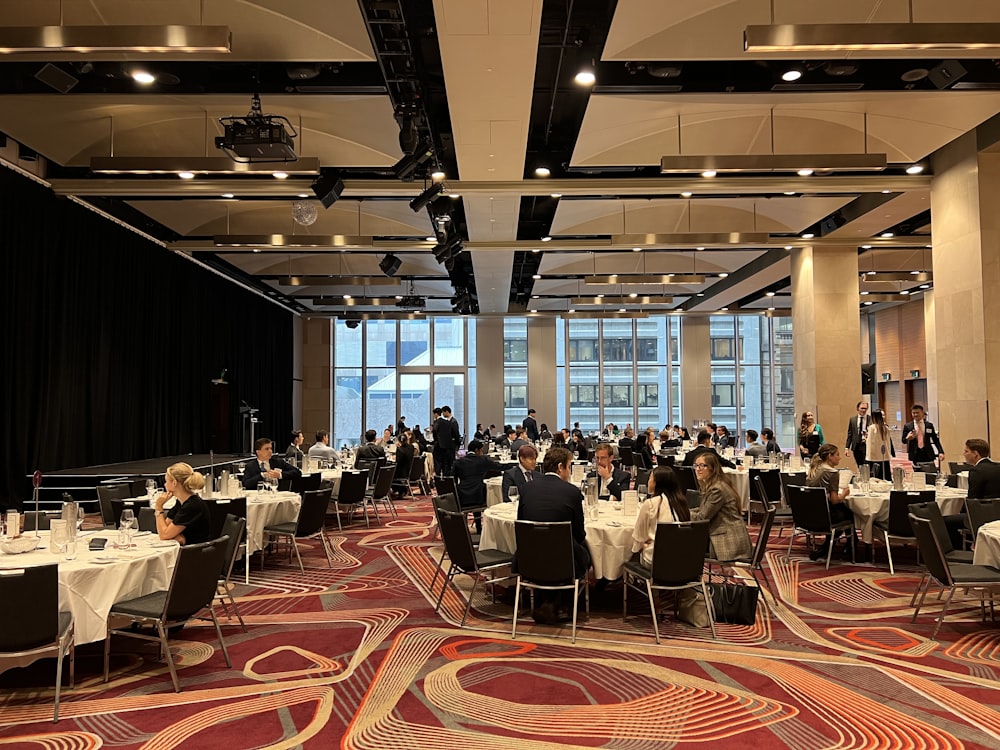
xmin=0 ymin=167 xmax=293 ymax=506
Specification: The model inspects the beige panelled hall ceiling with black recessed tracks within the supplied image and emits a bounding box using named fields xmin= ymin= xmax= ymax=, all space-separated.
xmin=0 ymin=0 xmax=1000 ymax=316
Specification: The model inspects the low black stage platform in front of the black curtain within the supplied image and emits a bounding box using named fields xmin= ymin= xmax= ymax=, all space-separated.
xmin=25 ymin=453 xmax=247 ymax=506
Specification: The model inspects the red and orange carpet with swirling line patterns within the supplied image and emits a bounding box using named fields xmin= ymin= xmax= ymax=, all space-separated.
xmin=0 ymin=498 xmax=1000 ymax=750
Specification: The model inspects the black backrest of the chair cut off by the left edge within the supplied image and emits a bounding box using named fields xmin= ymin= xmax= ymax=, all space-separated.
xmin=0 ymin=564 xmax=59 ymax=652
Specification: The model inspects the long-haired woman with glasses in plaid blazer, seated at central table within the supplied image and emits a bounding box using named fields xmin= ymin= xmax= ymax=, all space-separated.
xmin=691 ymin=451 xmax=751 ymax=562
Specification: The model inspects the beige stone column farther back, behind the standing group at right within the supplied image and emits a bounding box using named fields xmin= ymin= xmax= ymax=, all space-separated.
xmin=786 ymin=244 xmax=862 ymax=450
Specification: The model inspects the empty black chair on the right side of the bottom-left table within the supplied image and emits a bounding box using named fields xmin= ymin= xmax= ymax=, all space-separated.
xmin=104 ymin=537 xmax=233 ymax=693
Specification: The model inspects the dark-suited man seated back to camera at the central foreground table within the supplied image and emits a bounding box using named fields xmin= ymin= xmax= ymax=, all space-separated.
xmin=514 ymin=447 xmax=590 ymax=625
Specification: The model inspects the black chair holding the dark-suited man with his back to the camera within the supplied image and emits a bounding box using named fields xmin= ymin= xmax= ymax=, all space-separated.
xmin=510 ymin=521 xmax=590 ymax=643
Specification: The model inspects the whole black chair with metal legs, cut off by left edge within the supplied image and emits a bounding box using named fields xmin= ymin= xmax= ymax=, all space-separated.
xmin=0 ymin=564 xmax=76 ymax=722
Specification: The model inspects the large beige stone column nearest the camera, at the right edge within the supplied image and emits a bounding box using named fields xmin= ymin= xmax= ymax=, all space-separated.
xmin=927 ymin=133 xmax=1000 ymax=446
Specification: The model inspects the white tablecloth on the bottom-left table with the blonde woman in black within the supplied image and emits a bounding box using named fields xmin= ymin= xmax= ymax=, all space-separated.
xmin=0 ymin=530 xmax=180 ymax=643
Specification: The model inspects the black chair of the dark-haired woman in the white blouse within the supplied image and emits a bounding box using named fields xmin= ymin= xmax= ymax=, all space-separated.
xmin=620 ymin=521 xmax=715 ymax=643
